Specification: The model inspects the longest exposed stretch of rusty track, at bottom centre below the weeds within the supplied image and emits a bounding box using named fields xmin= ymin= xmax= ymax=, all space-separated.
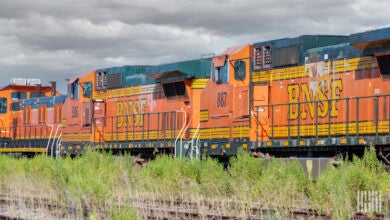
xmin=130 ymin=199 xmax=331 ymax=220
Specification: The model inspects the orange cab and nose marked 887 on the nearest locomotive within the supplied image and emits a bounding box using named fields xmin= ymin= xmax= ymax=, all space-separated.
xmin=200 ymin=45 xmax=252 ymax=155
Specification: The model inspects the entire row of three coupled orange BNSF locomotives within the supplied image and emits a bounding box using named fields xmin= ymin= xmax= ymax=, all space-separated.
xmin=0 ymin=28 xmax=390 ymax=168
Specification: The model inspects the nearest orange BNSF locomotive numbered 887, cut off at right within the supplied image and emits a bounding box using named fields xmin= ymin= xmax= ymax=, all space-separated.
xmin=199 ymin=28 xmax=390 ymax=165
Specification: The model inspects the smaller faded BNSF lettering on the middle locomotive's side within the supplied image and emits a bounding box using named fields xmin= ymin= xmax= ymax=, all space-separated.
xmin=116 ymin=99 xmax=146 ymax=128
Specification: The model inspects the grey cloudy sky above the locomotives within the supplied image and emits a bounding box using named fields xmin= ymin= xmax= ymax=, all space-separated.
xmin=0 ymin=0 xmax=390 ymax=92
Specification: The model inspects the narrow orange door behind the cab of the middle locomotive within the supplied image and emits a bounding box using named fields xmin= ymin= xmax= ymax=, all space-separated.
xmin=92 ymin=101 xmax=106 ymax=143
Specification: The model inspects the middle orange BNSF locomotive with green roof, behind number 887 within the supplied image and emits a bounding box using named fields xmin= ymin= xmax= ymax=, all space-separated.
xmin=61 ymin=58 xmax=211 ymax=157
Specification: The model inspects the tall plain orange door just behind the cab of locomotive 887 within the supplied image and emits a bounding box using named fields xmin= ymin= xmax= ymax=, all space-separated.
xmin=252 ymin=85 xmax=269 ymax=140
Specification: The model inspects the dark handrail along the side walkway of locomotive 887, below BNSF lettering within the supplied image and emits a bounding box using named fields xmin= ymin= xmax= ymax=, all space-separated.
xmin=251 ymin=94 xmax=390 ymax=142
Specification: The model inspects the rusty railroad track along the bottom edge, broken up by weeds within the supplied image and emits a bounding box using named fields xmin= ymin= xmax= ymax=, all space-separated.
xmin=0 ymin=194 xmax=390 ymax=220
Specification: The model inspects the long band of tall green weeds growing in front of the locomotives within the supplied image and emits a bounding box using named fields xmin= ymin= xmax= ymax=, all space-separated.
xmin=0 ymin=151 xmax=390 ymax=219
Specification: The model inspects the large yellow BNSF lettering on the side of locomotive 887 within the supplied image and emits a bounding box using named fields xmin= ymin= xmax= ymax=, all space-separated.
xmin=287 ymin=79 xmax=343 ymax=120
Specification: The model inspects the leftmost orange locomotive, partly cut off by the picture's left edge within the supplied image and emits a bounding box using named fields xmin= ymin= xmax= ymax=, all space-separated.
xmin=0 ymin=78 xmax=65 ymax=155
